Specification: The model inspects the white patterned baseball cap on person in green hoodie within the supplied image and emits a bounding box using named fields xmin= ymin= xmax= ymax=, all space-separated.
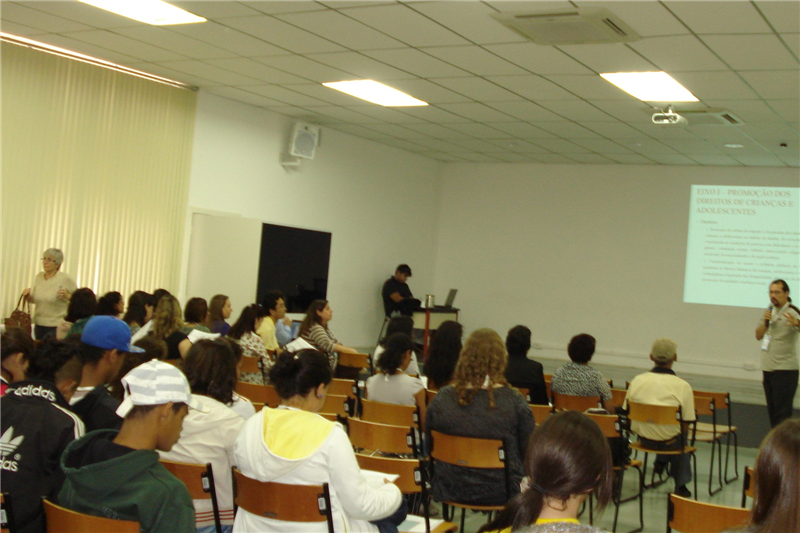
xmin=117 ymin=359 xmax=208 ymax=418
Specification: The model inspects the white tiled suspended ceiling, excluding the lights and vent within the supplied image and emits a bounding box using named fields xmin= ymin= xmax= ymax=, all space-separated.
xmin=0 ymin=0 xmax=800 ymax=167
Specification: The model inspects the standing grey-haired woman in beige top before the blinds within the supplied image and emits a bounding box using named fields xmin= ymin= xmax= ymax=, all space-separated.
xmin=22 ymin=248 xmax=77 ymax=340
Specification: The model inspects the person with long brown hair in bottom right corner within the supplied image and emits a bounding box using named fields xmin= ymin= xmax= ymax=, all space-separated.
xmin=728 ymin=418 xmax=800 ymax=533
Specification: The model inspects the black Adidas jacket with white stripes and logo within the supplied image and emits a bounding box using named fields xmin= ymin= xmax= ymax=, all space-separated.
xmin=0 ymin=380 xmax=83 ymax=533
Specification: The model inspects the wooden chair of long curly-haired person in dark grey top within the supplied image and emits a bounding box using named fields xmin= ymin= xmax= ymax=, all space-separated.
xmin=430 ymin=431 xmax=509 ymax=531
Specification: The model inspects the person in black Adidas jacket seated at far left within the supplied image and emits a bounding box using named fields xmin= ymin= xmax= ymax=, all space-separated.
xmin=0 ymin=338 xmax=84 ymax=533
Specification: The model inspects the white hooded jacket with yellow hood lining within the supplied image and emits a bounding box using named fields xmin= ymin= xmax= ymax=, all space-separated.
xmin=233 ymin=406 xmax=402 ymax=533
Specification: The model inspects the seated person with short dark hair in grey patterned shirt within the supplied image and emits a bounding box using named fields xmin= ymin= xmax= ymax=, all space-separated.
xmin=550 ymin=333 xmax=614 ymax=413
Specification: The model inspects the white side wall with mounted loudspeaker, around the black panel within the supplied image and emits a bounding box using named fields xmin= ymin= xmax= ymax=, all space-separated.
xmin=185 ymin=92 xmax=441 ymax=347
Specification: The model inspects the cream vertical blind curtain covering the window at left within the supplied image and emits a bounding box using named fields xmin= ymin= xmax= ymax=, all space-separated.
xmin=0 ymin=43 xmax=196 ymax=316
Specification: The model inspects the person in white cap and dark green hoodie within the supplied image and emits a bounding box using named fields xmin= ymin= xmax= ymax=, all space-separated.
xmin=58 ymin=361 xmax=198 ymax=533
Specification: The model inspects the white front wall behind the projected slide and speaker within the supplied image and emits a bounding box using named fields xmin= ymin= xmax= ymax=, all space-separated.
xmin=435 ymin=164 xmax=800 ymax=380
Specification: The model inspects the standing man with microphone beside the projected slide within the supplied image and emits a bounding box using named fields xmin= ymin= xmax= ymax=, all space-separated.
xmin=756 ymin=279 xmax=800 ymax=427
